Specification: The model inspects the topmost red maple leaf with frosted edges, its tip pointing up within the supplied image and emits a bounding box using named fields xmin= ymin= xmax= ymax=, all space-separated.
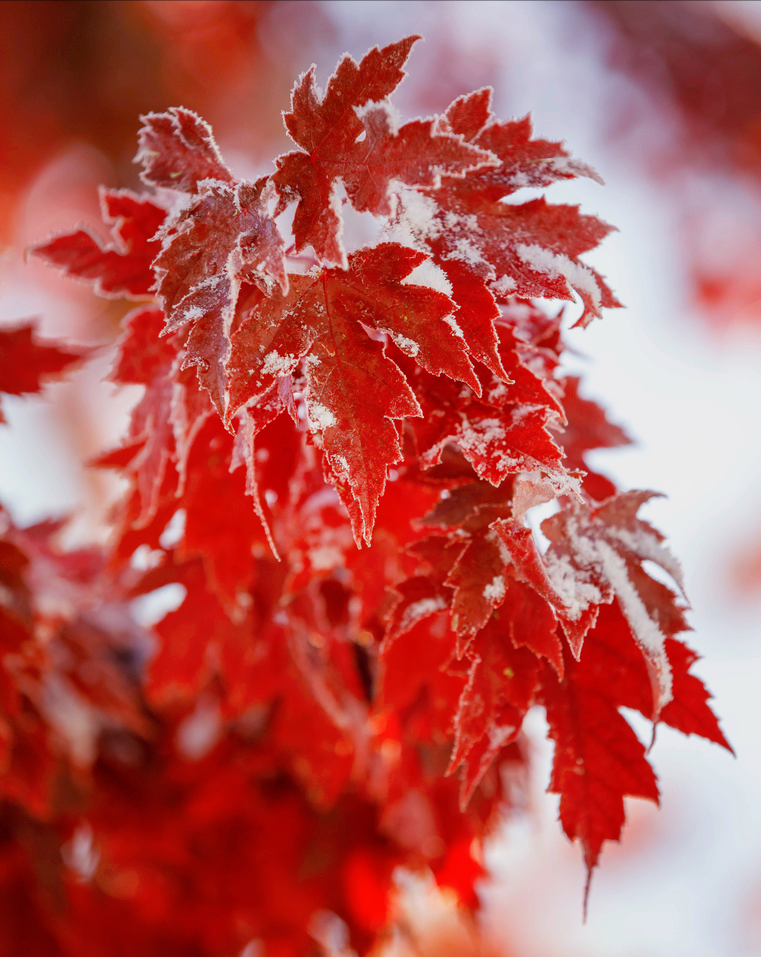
xmin=274 ymin=37 xmax=494 ymax=268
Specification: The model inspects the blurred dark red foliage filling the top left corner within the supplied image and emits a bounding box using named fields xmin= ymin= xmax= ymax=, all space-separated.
xmin=0 ymin=0 xmax=330 ymax=242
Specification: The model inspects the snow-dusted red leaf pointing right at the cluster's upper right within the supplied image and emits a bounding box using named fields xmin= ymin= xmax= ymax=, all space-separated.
xmin=388 ymin=84 xmax=619 ymax=324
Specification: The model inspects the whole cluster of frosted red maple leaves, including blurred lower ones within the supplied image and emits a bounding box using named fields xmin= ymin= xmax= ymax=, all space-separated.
xmin=0 ymin=37 xmax=728 ymax=957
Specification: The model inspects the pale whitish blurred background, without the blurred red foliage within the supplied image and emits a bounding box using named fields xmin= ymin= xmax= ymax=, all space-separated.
xmin=0 ymin=0 xmax=761 ymax=957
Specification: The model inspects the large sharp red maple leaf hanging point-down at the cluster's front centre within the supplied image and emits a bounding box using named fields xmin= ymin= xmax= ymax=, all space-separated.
xmin=229 ymin=244 xmax=486 ymax=540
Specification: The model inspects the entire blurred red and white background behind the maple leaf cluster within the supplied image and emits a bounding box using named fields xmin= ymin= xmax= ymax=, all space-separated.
xmin=0 ymin=0 xmax=761 ymax=957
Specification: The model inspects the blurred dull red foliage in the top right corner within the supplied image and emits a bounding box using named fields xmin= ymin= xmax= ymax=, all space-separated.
xmin=587 ymin=0 xmax=761 ymax=327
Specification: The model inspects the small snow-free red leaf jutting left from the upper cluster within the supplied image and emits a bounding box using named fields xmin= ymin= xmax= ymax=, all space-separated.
xmin=30 ymin=189 xmax=166 ymax=299
